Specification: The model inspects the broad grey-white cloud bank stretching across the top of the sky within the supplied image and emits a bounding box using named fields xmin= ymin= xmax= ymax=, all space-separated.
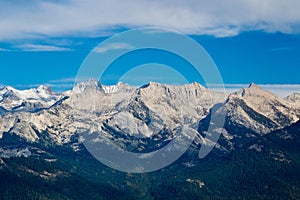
xmin=0 ymin=0 xmax=300 ymax=40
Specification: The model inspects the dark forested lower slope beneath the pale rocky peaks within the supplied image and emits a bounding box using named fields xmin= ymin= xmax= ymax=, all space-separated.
xmin=0 ymin=122 xmax=300 ymax=199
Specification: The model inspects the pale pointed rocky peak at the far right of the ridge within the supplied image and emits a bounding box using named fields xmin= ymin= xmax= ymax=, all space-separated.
xmin=223 ymin=83 xmax=300 ymax=133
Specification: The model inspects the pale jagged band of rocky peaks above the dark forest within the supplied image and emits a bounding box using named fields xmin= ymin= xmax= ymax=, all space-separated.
xmin=0 ymin=79 xmax=300 ymax=155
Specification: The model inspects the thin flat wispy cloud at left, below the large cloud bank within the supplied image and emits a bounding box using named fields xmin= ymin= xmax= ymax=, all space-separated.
xmin=15 ymin=44 xmax=72 ymax=51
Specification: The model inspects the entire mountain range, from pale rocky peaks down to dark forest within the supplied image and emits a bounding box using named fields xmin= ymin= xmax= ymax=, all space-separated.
xmin=0 ymin=79 xmax=300 ymax=199
